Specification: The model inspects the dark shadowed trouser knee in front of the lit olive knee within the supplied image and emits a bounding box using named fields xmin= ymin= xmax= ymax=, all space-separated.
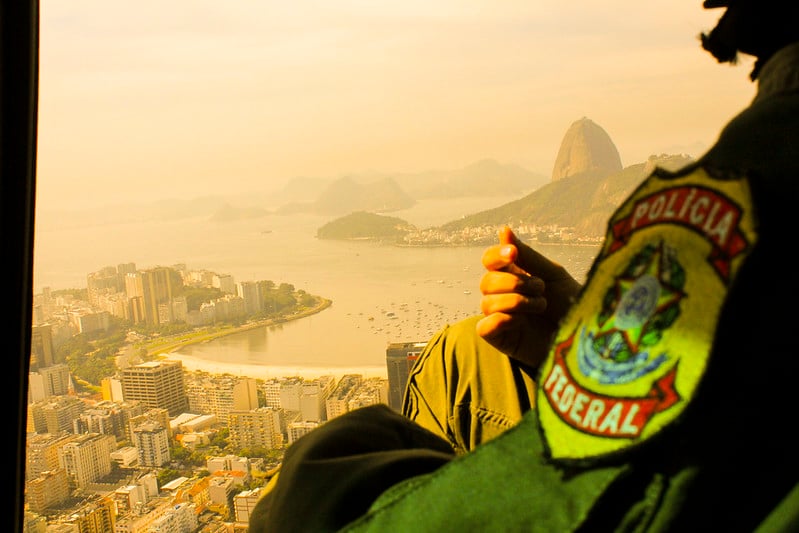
xmin=249 ymin=404 xmax=455 ymax=533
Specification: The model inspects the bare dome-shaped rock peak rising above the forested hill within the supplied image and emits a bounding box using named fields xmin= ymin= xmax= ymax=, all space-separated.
xmin=552 ymin=117 xmax=622 ymax=181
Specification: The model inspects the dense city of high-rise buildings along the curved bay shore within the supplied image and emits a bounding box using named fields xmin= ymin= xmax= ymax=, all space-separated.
xmin=25 ymin=264 xmax=412 ymax=532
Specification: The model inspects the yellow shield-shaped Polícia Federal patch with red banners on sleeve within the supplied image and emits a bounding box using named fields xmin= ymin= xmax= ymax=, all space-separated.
xmin=537 ymin=168 xmax=757 ymax=460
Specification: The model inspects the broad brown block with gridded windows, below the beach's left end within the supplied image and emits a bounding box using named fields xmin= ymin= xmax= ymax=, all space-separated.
xmin=120 ymin=361 xmax=189 ymax=416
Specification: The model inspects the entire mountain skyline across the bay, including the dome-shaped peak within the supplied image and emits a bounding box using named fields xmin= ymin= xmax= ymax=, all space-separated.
xmin=37 ymin=117 xmax=692 ymax=239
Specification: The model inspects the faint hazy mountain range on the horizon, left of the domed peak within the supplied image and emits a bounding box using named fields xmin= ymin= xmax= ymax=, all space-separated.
xmin=37 ymin=155 xmax=548 ymax=228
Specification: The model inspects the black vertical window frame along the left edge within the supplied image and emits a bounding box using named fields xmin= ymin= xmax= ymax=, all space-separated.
xmin=0 ymin=0 xmax=39 ymax=532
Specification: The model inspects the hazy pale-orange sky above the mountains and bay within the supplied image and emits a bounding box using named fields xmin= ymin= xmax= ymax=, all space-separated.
xmin=37 ymin=0 xmax=756 ymax=209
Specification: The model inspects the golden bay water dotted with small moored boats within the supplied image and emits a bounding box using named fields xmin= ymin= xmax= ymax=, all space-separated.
xmin=34 ymin=198 xmax=598 ymax=377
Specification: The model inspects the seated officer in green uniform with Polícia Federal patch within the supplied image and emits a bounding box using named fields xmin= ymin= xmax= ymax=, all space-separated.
xmin=250 ymin=0 xmax=799 ymax=532
